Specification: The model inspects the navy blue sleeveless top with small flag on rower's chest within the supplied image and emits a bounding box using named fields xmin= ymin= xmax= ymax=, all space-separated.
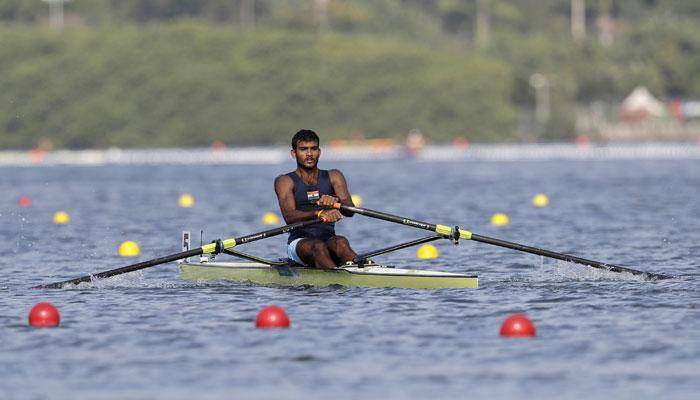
xmin=287 ymin=169 xmax=335 ymax=244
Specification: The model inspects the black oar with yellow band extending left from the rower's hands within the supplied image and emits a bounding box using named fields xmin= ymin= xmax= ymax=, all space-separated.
xmin=36 ymin=219 xmax=321 ymax=289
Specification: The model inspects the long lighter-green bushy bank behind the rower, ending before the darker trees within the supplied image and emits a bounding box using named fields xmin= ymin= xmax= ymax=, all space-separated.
xmin=0 ymin=22 xmax=514 ymax=148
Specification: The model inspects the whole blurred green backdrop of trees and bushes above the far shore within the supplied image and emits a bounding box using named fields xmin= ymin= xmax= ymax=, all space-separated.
xmin=0 ymin=0 xmax=700 ymax=148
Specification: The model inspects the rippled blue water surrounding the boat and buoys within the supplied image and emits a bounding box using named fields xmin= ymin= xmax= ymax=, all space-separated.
xmin=0 ymin=160 xmax=700 ymax=399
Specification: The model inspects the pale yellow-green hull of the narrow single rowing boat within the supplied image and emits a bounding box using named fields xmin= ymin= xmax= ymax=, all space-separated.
xmin=179 ymin=262 xmax=479 ymax=289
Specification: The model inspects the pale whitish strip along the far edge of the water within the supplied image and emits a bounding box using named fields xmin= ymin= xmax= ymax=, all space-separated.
xmin=0 ymin=143 xmax=700 ymax=167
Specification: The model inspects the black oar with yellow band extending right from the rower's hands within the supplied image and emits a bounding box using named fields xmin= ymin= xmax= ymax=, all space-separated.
xmin=333 ymin=203 xmax=671 ymax=279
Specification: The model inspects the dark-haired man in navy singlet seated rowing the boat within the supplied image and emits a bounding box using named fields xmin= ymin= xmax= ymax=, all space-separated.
xmin=275 ymin=129 xmax=357 ymax=269
